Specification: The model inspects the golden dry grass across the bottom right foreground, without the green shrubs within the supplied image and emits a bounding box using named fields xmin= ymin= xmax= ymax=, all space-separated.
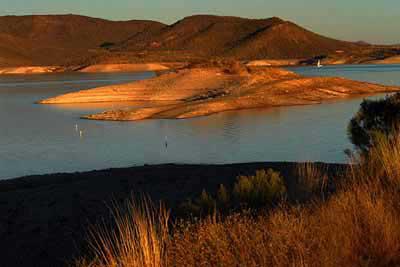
xmin=76 ymin=134 xmax=400 ymax=267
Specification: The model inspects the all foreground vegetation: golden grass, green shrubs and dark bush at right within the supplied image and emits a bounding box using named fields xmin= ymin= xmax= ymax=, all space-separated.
xmin=75 ymin=95 xmax=400 ymax=267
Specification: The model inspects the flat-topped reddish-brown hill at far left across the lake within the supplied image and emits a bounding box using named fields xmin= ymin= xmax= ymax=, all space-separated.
xmin=0 ymin=15 xmax=165 ymax=66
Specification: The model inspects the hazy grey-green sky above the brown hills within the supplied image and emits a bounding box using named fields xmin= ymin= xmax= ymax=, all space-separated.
xmin=0 ymin=0 xmax=400 ymax=44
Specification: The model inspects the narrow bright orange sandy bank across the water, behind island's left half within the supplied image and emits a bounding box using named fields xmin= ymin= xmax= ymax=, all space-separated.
xmin=79 ymin=63 xmax=169 ymax=73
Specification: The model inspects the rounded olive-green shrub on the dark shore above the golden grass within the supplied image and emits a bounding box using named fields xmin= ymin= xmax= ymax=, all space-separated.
xmin=233 ymin=169 xmax=286 ymax=208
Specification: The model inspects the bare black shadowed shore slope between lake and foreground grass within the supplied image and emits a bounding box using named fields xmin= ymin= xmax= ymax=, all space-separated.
xmin=0 ymin=163 xmax=344 ymax=267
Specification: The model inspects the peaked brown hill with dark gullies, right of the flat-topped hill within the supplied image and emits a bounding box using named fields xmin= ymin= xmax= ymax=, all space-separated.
xmin=115 ymin=15 xmax=360 ymax=59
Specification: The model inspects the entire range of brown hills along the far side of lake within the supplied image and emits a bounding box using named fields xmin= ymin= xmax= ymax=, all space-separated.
xmin=0 ymin=15 xmax=363 ymax=65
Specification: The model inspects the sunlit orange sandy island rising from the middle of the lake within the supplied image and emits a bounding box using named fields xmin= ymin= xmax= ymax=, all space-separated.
xmin=40 ymin=68 xmax=400 ymax=121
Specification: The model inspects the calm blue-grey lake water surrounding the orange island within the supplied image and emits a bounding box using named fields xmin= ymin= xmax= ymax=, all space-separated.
xmin=0 ymin=65 xmax=400 ymax=179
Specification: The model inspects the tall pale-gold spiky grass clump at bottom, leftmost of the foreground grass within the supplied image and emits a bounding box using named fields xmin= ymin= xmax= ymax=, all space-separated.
xmin=79 ymin=199 xmax=169 ymax=267
